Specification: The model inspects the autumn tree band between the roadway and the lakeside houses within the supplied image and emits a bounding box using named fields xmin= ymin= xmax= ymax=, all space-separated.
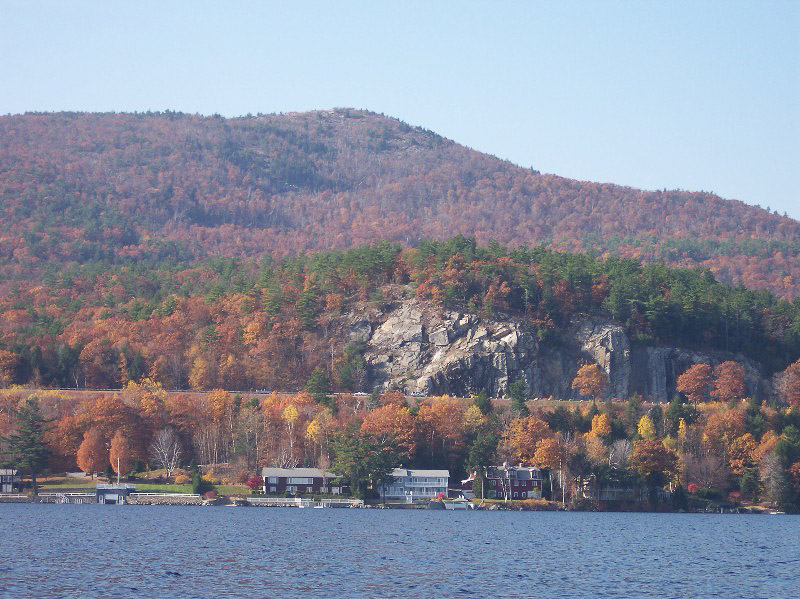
xmin=0 ymin=384 xmax=800 ymax=511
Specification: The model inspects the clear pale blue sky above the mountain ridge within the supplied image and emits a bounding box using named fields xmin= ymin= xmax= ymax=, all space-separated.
xmin=0 ymin=0 xmax=800 ymax=218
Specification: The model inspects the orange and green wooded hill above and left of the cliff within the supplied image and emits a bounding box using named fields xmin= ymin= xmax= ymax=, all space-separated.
xmin=0 ymin=236 xmax=800 ymax=391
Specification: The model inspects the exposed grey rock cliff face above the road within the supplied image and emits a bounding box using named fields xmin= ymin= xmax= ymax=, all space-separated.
xmin=349 ymin=300 xmax=766 ymax=402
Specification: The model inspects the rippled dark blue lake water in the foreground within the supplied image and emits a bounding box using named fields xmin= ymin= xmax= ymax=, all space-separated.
xmin=0 ymin=504 xmax=800 ymax=599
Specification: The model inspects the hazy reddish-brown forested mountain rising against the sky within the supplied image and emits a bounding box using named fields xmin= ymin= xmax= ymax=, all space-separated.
xmin=0 ymin=109 xmax=800 ymax=299
